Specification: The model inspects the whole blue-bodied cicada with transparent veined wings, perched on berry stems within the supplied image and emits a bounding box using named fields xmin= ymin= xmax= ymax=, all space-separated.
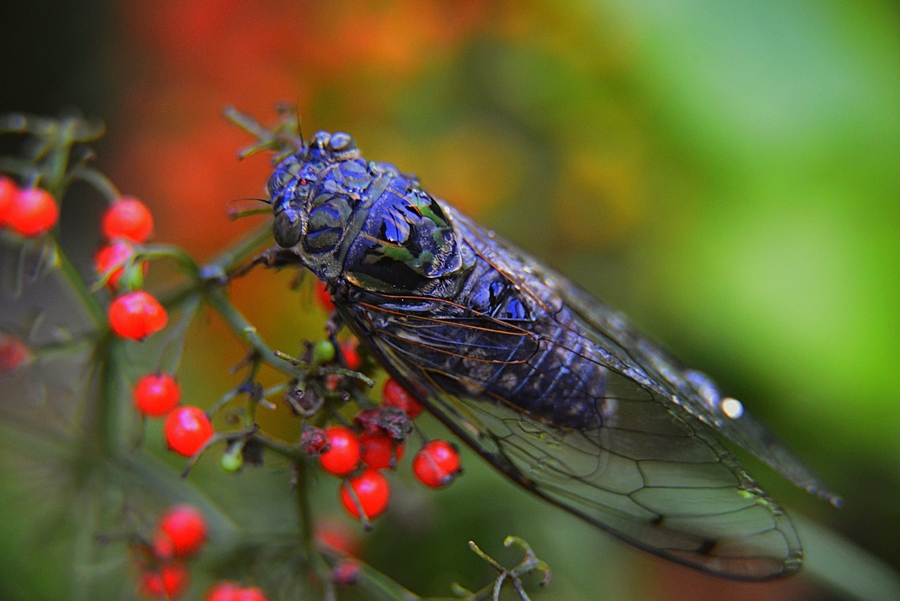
xmin=258 ymin=132 xmax=839 ymax=580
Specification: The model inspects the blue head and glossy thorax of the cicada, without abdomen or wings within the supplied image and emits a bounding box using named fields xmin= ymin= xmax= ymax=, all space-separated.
xmin=267 ymin=131 xmax=472 ymax=292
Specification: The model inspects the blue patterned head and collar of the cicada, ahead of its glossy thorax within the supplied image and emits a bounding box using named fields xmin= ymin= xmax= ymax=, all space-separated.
xmin=266 ymin=131 xmax=373 ymax=280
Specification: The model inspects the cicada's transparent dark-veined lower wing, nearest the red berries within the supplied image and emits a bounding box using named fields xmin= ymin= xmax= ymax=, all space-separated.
xmin=344 ymin=298 xmax=802 ymax=580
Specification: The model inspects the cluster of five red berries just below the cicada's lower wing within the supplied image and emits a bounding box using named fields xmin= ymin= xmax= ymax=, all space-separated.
xmin=319 ymin=379 xmax=461 ymax=520
